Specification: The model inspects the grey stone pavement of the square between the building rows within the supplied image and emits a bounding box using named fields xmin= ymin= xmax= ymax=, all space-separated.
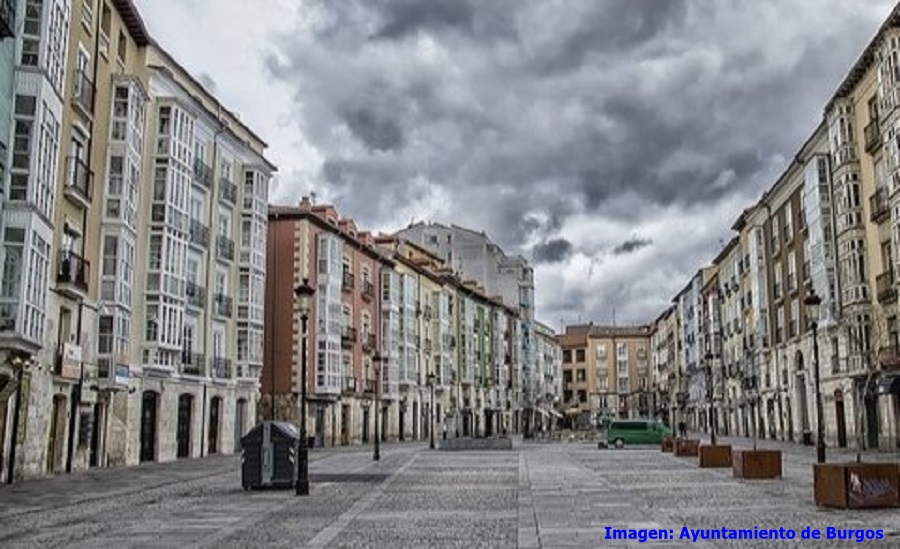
xmin=0 ymin=438 xmax=900 ymax=548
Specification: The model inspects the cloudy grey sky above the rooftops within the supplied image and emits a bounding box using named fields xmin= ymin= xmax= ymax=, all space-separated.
xmin=135 ymin=0 xmax=895 ymax=330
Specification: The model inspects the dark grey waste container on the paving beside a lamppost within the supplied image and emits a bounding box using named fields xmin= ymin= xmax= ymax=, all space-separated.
xmin=241 ymin=421 xmax=300 ymax=490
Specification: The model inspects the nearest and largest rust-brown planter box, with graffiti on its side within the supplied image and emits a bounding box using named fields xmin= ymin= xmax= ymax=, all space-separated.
xmin=813 ymin=462 xmax=900 ymax=509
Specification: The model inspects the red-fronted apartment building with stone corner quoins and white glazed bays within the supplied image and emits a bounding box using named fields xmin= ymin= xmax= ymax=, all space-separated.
xmin=259 ymin=198 xmax=386 ymax=445
